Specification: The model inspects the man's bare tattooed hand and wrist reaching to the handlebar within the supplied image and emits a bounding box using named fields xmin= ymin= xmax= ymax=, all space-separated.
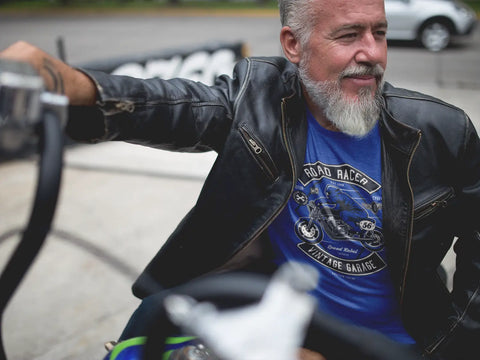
xmin=0 ymin=41 xmax=96 ymax=105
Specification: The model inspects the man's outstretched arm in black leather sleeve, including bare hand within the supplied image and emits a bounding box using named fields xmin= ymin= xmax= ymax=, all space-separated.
xmin=0 ymin=42 xmax=240 ymax=152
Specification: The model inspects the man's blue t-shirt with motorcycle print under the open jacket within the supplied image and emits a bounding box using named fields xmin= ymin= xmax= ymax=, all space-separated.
xmin=268 ymin=112 xmax=415 ymax=344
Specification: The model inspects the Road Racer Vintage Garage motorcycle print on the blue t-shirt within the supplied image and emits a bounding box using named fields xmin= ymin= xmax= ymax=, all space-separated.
xmin=292 ymin=161 xmax=386 ymax=276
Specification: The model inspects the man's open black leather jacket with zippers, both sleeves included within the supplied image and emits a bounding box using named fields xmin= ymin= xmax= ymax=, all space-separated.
xmin=67 ymin=58 xmax=480 ymax=360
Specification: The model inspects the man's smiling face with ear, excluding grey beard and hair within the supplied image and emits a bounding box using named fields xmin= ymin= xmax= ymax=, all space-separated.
xmin=301 ymin=0 xmax=387 ymax=101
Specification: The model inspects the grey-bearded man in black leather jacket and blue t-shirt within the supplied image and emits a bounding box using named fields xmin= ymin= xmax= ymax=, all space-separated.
xmin=2 ymin=0 xmax=480 ymax=360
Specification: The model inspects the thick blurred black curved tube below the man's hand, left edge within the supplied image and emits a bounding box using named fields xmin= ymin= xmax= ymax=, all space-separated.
xmin=0 ymin=111 xmax=63 ymax=360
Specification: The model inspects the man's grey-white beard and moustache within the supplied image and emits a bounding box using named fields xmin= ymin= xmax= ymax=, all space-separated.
xmin=298 ymin=62 xmax=383 ymax=137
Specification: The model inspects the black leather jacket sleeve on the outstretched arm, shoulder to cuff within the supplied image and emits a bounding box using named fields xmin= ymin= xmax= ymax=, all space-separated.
xmin=66 ymin=61 xmax=246 ymax=152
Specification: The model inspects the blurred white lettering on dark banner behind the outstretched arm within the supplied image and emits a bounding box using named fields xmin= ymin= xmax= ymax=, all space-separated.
xmin=112 ymin=49 xmax=235 ymax=85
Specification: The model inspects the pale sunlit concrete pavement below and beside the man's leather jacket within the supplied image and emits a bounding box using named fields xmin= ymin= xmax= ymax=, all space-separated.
xmin=0 ymin=57 xmax=480 ymax=360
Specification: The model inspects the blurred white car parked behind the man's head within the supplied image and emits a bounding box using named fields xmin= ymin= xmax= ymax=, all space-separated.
xmin=385 ymin=0 xmax=477 ymax=51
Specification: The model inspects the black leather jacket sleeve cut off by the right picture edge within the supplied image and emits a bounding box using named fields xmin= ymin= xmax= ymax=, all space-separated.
xmin=441 ymin=114 xmax=480 ymax=359
